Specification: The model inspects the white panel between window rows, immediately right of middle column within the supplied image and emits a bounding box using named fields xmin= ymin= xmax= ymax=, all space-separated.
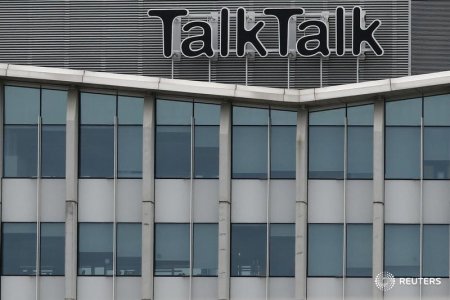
xmin=231 ymin=179 xmax=267 ymax=223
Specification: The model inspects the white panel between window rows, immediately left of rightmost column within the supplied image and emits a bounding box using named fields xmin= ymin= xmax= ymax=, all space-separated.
xmin=345 ymin=180 xmax=373 ymax=223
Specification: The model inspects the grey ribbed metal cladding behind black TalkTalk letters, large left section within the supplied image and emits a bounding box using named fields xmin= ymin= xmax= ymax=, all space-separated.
xmin=0 ymin=0 xmax=410 ymax=88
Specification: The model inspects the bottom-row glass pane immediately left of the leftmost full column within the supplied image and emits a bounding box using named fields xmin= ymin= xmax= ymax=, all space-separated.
xmin=40 ymin=223 xmax=65 ymax=276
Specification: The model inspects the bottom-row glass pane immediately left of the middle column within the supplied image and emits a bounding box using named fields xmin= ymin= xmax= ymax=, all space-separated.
xmin=192 ymin=224 xmax=219 ymax=276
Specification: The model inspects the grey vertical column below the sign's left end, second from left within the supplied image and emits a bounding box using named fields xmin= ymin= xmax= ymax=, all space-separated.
xmin=142 ymin=93 xmax=155 ymax=300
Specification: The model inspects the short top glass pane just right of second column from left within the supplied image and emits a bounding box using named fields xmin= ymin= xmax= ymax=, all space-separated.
xmin=156 ymin=100 xmax=193 ymax=125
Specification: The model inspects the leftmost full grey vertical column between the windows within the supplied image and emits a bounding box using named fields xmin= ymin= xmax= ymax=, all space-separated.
xmin=65 ymin=87 xmax=78 ymax=300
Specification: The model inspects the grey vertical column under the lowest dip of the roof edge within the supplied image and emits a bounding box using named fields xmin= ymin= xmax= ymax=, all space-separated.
xmin=295 ymin=108 xmax=308 ymax=300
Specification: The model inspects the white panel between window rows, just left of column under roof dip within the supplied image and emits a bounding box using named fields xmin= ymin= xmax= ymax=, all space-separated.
xmin=270 ymin=180 xmax=295 ymax=223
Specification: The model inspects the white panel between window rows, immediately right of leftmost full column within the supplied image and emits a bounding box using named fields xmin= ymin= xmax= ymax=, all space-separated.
xmin=78 ymin=179 xmax=114 ymax=222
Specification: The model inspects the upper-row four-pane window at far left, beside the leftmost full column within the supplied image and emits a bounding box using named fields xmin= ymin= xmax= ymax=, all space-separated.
xmin=3 ymin=86 xmax=67 ymax=177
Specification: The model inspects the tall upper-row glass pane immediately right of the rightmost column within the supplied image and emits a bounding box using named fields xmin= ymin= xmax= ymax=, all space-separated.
xmin=385 ymin=127 xmax=420 ymax=179
